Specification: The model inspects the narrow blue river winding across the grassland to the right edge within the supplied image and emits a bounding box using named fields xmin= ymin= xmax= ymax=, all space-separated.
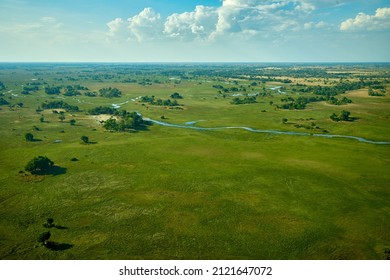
xmin=144 ymin=118 xmax=390 ymax=145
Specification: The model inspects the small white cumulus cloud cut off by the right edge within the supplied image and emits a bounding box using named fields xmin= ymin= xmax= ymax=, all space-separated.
xmin=340 ymin=8 xmax=390 ymax=31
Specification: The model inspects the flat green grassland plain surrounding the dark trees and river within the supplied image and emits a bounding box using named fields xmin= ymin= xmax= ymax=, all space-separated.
xmin=0 ymin=65 xmax=390 ymax=259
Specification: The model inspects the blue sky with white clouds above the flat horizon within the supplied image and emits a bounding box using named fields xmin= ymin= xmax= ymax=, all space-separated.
xmin=0 ymin=0 xmax=390 ymax=62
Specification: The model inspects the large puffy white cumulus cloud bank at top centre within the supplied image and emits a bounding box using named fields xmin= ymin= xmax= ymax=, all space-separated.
xmin=107 ymin=0 xmax=334 ymax=41
